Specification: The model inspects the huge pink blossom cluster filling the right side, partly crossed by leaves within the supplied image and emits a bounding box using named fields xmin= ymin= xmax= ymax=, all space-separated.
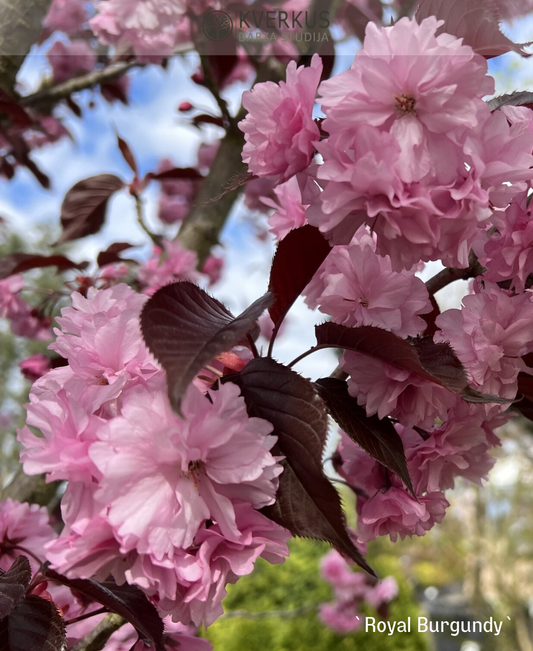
xmin=240 ymin=17 xmax=533 ymax=541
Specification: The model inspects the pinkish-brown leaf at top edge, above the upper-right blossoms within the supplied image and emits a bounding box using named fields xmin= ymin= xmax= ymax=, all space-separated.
xmin=416 ymin=0 xmax=530 ymax=59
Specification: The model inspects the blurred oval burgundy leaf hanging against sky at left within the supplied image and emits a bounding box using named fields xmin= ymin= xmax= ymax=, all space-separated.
xmin=58 ymin=174 xmax=124 ymax=243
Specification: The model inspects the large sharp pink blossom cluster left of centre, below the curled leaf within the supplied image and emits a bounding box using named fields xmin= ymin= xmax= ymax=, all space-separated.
xmin=19 ymin=284 xmax=289 ymax=625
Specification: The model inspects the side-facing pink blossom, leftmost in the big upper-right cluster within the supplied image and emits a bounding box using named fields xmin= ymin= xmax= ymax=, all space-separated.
xmin=239 ymin=55 xmax=322 ymax=183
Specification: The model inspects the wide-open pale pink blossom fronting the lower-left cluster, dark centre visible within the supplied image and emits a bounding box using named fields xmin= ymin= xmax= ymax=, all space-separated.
xmin=89 ymin=378 xmax=281 ymax=558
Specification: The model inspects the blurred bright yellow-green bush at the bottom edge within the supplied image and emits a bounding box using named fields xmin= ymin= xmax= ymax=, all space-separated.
xmin=206 ymin=540 xmax=428 ymax=651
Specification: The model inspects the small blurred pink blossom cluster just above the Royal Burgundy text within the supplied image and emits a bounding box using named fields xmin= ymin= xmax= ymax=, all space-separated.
xmin=319 ymin=550 xmax=398 ymax=633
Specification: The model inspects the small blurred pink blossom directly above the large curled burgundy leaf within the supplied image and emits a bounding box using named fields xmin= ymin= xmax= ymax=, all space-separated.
xmin=137 ymin=240 xmax=199 ymax=296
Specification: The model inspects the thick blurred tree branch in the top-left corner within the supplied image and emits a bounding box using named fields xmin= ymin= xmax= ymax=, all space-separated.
xmin=0 ymin=0 xmax=52 ymax=94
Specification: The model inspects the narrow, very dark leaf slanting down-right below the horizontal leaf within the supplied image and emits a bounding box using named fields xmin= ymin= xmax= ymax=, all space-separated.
xmin=315 ymin=378 xmax=416 ymax=498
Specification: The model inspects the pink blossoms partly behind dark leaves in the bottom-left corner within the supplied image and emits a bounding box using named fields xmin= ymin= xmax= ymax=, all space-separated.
xmin=0 ymin=499 xmax=212 ymax=651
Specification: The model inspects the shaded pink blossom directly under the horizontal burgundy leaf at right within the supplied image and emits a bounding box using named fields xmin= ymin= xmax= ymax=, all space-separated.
xmin=341 ymin=351 xmax=455 ymax=428
